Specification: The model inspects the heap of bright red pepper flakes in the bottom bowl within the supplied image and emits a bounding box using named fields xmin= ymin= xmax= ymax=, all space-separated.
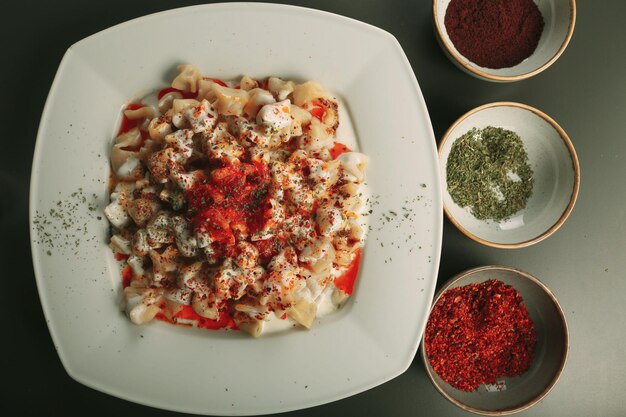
xmin=424 ymin=279 xmax=537 ymax=391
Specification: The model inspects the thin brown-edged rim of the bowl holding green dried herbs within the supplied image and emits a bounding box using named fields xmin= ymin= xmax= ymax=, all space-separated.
xmin=438 ymin=101 xmax=580 ymax=249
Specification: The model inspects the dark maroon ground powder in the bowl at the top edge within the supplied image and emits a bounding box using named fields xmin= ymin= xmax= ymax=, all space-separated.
xmin=445 ymin=0 xmax=544 ymax=69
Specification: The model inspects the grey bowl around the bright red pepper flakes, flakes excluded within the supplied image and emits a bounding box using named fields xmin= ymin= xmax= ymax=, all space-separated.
xmin=421 ymin=265 xmax=569 ymax=416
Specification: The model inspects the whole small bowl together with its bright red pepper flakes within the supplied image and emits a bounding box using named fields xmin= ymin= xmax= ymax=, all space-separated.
xmin=421 ymin=265 xmax=569 ymax=416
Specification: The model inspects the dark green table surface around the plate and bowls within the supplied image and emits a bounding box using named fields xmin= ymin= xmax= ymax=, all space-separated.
xmin=0 ymin=0 xmax=626 ymax=417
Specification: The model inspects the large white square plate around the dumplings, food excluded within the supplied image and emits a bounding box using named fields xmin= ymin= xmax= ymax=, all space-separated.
xmin=30 ymin=3 xmax=442 ymax=415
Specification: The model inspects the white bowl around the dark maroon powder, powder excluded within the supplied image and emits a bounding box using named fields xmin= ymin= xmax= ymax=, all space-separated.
xmin=433 ymin=0 xmax=576 ymax=82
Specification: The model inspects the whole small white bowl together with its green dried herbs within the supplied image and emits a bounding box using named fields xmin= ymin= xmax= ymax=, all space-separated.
xmin=439 ymin=102 xmax=580 ymax=248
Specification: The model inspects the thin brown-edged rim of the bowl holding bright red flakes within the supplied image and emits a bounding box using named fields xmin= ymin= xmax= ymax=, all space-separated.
xmin=420 ymin=265 xmax=569 ymax=416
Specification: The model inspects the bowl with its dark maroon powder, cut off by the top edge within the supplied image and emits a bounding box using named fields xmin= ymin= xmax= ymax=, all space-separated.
xmin=433 ymin=0 xmax=576 ymax=82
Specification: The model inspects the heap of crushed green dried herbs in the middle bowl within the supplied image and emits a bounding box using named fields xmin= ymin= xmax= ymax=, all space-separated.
xmin=446 ymin=126 xmax=534 ymax=221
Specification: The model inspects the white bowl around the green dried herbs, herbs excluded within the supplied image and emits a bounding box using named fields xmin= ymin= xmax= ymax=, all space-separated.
xmin=439 ymin=102 xmax=580 ymax=249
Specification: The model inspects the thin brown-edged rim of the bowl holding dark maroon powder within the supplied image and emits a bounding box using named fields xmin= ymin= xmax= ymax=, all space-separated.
xmin=433 ymin=0 xmax=576 ymax=82
